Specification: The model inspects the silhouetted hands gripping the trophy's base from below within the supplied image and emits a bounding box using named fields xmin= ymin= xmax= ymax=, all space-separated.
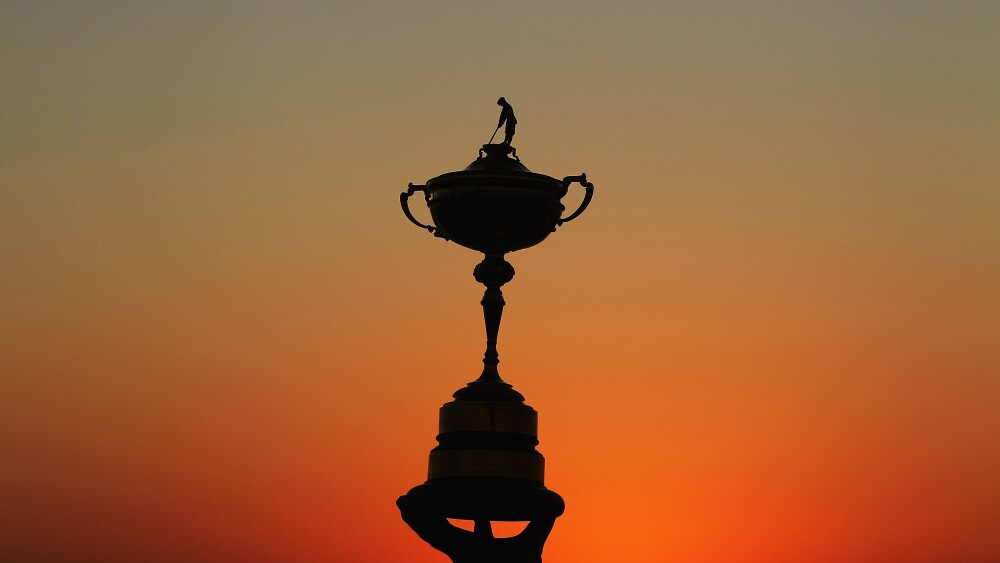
xmin=396 ymin=495 xmax=555 ymax=563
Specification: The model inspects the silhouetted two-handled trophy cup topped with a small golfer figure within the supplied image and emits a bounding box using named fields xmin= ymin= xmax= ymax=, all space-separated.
xmin=399 ymin=98 xmax=594 ymax=560
